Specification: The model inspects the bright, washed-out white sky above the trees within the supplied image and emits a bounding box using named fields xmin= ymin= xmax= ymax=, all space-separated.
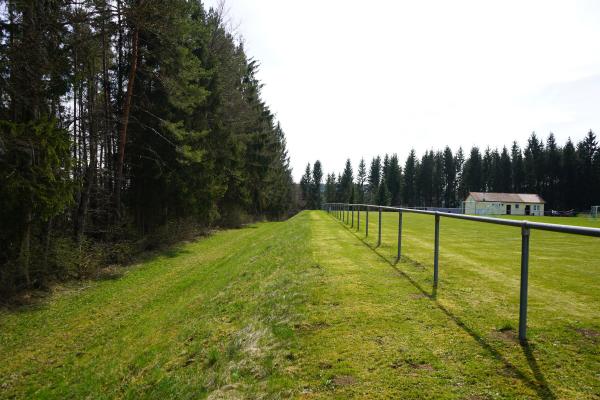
xmin=207 ymin=0 xmax=600 ymax=180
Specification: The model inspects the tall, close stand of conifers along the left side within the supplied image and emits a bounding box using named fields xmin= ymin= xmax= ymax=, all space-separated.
xmin=0 ymin=0 xmax=293 ymax=296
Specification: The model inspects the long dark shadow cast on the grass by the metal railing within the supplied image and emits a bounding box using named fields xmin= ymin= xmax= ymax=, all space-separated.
xmin=333 ymin=212 xmax=556 ymax=400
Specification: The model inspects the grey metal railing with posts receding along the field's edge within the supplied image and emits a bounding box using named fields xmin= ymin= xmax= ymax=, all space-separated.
xmin=324 ymin=203 xmax=600 ymax=343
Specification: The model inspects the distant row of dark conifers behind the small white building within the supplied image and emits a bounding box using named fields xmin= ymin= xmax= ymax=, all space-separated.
xmin=300 ymin=131 xmax=600 ymax=211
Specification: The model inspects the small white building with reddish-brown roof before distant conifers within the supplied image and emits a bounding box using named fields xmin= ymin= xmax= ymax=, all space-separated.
xmin=463 ymin=192 xmax=545 ymax=215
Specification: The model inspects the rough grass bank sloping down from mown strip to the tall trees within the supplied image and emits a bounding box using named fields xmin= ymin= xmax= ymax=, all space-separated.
xmin=0 ymin=215 xmax=313 ymax=399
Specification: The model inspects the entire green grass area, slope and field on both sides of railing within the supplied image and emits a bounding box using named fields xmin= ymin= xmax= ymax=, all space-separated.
xmin=0 ymin=211 xmax=600 ymax=400
